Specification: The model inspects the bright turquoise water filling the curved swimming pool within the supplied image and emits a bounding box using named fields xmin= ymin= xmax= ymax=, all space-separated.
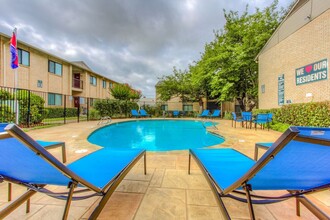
xmin=88 ymin=120 xmax=224 ymax=151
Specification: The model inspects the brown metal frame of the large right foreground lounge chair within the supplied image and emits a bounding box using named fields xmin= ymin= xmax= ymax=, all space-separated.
xmin=188 ymin=127 xmax=330 ymax=219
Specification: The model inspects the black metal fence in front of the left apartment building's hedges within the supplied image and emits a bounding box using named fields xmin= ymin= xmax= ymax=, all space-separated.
xmin=0 ymin=87 xmax=95 ymax=127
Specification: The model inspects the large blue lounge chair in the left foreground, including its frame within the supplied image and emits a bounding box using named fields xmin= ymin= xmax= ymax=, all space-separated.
xmin=0 ymin=124 xmax=146 ymax=219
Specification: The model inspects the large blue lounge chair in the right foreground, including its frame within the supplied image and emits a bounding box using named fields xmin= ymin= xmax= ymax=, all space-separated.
xmin=188 ymin=127 xmax=330 ymax=219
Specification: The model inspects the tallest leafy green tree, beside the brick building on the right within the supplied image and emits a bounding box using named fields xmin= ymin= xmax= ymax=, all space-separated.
xmin=190 ymin=1 xmax=284 ymax=111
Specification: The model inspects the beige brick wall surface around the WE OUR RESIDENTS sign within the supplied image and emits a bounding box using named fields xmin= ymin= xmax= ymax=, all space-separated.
xmin=258 ymin=10 xmax=330 ymax=109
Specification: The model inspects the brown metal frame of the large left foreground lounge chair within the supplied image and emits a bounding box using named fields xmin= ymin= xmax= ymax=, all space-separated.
xmin=0 ymin=124 xmax=147 ymax=219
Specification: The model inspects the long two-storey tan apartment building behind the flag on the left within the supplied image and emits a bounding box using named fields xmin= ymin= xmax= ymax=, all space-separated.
xmin=0 ymin=33 xmax=117 ymax=107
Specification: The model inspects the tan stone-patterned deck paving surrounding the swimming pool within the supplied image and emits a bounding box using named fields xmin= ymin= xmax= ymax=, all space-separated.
xmin=0 ymin=119 xmax=330 ymax=220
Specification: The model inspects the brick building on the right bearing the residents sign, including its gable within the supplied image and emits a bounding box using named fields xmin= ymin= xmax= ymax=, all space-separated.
xmin=257 ymin=0 xmax=330 ymax=109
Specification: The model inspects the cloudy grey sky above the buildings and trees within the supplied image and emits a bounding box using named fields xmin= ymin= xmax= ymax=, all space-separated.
xmin=0 ymin=0 xmax=293 ymax=98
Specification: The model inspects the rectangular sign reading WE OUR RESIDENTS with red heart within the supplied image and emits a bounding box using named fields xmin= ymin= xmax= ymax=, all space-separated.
xmin=296 ymin=59 xmax=328 ymax=86
